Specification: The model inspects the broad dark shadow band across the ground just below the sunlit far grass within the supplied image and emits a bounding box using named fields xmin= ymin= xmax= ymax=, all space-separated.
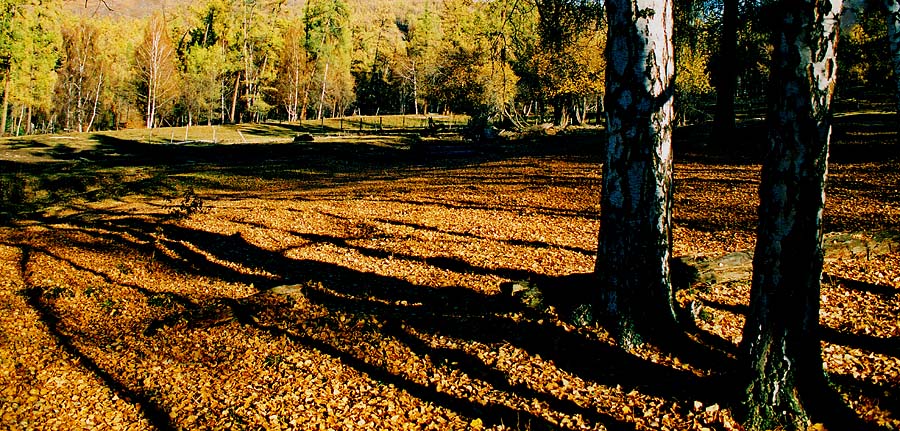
xmin=0 ymin=132 xmax=599 ymax=230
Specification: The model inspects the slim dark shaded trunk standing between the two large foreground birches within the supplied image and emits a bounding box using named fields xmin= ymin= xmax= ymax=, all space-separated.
xmin=712 ymin=0 xmax=738 ymax=146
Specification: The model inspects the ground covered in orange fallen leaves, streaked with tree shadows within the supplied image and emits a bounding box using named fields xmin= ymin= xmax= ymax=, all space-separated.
xmin=0 ymin=113 xmax=900 ymax=430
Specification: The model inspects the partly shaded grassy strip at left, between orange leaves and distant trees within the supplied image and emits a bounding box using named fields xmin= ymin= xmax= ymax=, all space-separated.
xmin=0 ymin=116 xmax=478 ymax=220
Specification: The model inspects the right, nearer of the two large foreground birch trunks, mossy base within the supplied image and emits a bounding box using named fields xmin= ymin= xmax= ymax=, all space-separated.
xmin=741 ymin=0 xmax=841 ymax=431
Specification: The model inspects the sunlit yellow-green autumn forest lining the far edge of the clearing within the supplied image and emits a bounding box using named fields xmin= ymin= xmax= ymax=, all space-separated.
xmin=0 ymin=0 xmax=892 ymax=135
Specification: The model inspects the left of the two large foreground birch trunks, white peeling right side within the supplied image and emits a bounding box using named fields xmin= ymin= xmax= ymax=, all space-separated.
xmin=595 ymin=0 xmax=675 ymax=347
